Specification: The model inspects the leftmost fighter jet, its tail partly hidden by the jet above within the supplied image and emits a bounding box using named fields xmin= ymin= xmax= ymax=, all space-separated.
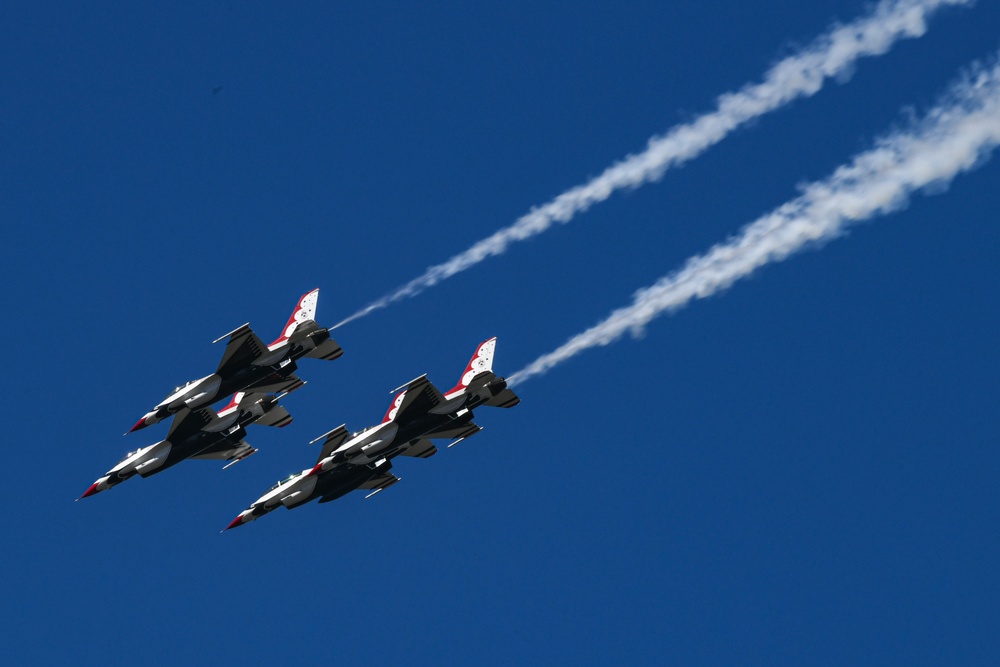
xmin=80 ymin=383 xmax=302 ymax=498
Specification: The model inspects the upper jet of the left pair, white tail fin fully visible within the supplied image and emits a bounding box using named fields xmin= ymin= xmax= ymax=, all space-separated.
xmin=129 ymin=289 xmax=344 ymax=433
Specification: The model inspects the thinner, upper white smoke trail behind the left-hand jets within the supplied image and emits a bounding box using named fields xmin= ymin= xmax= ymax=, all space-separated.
xmin=333 ymin=0 xmax=973 ymax=329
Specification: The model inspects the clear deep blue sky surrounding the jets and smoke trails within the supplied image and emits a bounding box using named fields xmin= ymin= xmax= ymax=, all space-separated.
xmin=0 ymin=0 xmax=1000 ymax=665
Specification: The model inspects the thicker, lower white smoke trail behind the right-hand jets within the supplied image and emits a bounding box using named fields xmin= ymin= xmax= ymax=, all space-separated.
xmin=508 ymin=61 xmax=1000 ymax=384
